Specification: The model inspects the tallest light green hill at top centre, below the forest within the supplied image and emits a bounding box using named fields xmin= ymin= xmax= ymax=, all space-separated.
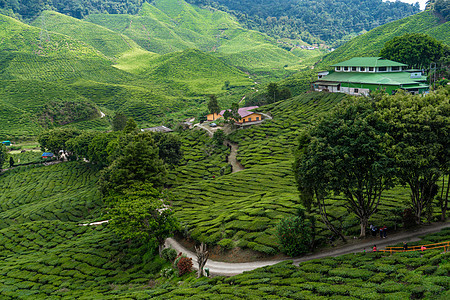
xmin=86 ymin=0 xmax=306 ymax=77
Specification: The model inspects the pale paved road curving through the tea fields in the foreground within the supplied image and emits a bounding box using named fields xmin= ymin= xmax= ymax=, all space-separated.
xmin=166 ymin=222 xmax=450 ymax=276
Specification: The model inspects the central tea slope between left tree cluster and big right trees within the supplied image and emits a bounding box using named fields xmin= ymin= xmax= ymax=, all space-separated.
xmin=171 ymin=93 xmax=428 ymax=255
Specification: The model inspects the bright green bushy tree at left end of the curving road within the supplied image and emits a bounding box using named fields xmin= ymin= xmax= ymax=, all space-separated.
xmin=107 ymin=183 xmax=179 ymax=254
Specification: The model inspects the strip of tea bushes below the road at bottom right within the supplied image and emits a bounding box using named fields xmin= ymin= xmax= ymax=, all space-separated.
xmin=82 ymin=229 xmax=450 ymax=300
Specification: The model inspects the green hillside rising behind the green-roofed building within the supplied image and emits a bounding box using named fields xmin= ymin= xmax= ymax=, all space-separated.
xmin=320 ymin=10 xmax=450 ymax=66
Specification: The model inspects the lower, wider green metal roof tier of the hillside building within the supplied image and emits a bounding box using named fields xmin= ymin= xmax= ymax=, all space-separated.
xmin=317 ymin=72 xmax=430 ymax=85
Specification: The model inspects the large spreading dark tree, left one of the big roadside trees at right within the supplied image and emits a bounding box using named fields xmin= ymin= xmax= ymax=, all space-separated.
xmin=294 ymin=98 xmax=395 ymax=237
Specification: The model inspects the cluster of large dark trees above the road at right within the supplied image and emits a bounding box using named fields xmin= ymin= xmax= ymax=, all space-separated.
xmin=294 ymin=87 xmax=450 ymax=244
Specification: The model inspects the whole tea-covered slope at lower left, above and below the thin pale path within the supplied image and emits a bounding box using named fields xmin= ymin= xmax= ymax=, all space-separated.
xmin=0 ymin=162 xmax=172 ymax=299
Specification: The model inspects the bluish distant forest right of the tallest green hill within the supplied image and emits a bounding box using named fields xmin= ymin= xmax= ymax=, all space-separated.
xmin=187 ymin=0 xmax=420 ymax=42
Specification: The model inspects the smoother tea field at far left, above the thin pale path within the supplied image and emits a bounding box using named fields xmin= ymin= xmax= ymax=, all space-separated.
xmin=0 ymin=162 xmax=102 ymax=228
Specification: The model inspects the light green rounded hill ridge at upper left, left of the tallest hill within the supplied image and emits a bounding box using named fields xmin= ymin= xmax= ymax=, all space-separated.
xmin=32 ymin=11 xmax=139 ymax=58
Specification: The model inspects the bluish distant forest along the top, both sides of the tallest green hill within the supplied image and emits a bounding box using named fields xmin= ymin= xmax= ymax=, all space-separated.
xmin=0 ymin=0 xmax=419 ymax=44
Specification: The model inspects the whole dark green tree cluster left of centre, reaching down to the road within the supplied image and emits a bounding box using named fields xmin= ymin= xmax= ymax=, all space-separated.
xmin=38 ymin=117 xmax=182 ymax=253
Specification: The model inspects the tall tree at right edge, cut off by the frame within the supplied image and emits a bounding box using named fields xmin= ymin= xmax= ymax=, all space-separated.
xmin=378 ymin=88 xmax=450 ymax=224
